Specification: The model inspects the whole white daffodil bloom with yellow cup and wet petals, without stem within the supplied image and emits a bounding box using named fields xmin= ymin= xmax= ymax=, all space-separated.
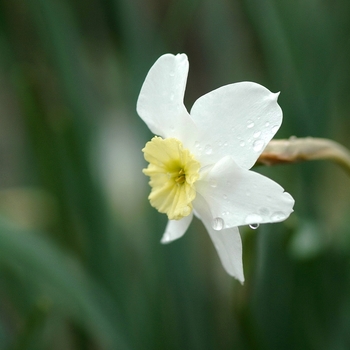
xmin=137 ymin=54 xmax=294 ymax=283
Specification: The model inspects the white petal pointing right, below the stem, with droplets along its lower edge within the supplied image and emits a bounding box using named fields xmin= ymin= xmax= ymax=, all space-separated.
xmin=196 ymin=157 xmax=294 ymax=228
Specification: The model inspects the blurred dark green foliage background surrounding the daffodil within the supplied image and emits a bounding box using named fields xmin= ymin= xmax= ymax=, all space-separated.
xmin=0 ymin=0 xmax=350 ymax=350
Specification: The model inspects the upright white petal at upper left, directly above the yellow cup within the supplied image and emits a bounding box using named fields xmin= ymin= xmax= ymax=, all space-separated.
xmin=136 ymin=54 xmax=194 ymax=140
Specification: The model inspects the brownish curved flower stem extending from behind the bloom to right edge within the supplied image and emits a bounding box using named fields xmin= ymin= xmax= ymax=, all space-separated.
xmin=256 ymin=137 xmax=350 ymax=175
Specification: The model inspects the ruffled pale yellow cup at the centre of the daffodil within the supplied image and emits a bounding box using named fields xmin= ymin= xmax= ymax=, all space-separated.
xmin=142 ymin=136 xmax=200 ymax=220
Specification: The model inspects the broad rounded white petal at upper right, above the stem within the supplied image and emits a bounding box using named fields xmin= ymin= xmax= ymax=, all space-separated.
xmin=191 ymin=82 xmax=282 ymax=169
